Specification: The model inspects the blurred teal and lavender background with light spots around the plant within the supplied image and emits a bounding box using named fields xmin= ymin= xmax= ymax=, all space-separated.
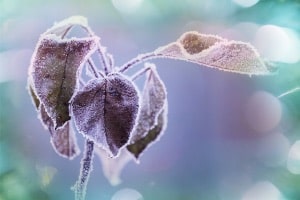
xmin=0 ymin=0 xmax=300 ymax=200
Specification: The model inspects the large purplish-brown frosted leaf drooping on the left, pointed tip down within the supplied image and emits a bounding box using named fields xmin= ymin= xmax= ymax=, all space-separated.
xmin=29 ymin=35 xmax=97 ymax=128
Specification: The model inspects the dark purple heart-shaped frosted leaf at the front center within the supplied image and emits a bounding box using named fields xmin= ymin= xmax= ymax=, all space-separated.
xmin=72 ymin=73 xmax=139 ymax=156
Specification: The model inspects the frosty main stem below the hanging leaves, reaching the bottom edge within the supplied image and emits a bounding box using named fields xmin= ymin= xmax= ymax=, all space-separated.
xmin=72 ymin=139 xmax=94 ymax=200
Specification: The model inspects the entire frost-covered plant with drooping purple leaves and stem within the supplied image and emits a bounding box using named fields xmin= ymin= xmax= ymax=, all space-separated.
xmin=28 ymin=16 xmax=273 ymax=200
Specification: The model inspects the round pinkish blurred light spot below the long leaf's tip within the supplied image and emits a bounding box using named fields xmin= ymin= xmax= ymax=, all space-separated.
xmin=246 ymin=91 xmax=282 ymax=133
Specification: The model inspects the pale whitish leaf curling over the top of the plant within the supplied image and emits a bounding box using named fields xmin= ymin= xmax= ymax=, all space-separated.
xmin=44 ymin=16 xmax=88 ymax=36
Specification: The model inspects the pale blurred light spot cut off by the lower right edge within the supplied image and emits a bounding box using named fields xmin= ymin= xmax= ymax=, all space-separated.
xmin=287 ymin=140 xmax=300 ymax=174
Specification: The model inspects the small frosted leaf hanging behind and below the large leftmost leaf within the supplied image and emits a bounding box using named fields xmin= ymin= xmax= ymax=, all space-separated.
xmin=40 ymin=105 xmax=80 ymax=159
